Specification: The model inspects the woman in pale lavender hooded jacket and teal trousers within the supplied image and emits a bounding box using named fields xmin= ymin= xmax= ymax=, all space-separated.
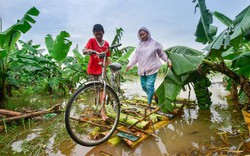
xmin=126 ymin=27 xmax=172 ymax=109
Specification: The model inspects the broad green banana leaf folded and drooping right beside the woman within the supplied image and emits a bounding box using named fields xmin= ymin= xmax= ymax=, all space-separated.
xmin=156 ymin=46 xmax=204 ymax=111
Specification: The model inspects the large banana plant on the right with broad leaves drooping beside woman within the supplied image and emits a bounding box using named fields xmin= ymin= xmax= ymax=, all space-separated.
xmin=156 ymin=0 xmax=250 ymax=111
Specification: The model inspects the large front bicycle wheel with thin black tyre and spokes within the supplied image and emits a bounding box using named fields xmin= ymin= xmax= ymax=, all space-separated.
xmin=65 ymin=82 xmax=120 ymax=146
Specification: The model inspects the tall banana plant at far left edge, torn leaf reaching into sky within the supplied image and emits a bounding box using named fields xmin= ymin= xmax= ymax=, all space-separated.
xmin=0 ymin=7 xmax=39 ymax=107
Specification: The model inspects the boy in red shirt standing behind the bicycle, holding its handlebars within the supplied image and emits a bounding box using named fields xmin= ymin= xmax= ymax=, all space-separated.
xmin=83 ymin=24 xmax=110 ymax=121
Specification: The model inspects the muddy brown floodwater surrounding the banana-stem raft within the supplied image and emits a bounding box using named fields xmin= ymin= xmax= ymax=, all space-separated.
xmin=0 ymin=75 xmax=248 ymax=156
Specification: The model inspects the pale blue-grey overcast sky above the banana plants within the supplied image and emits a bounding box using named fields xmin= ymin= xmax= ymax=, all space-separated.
xmin=0 ymin=0 xmax=250 ymax=50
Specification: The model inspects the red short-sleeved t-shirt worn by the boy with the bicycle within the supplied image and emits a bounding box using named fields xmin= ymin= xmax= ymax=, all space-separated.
xmin=85 ymin=38 xmax=110 ymax=75
